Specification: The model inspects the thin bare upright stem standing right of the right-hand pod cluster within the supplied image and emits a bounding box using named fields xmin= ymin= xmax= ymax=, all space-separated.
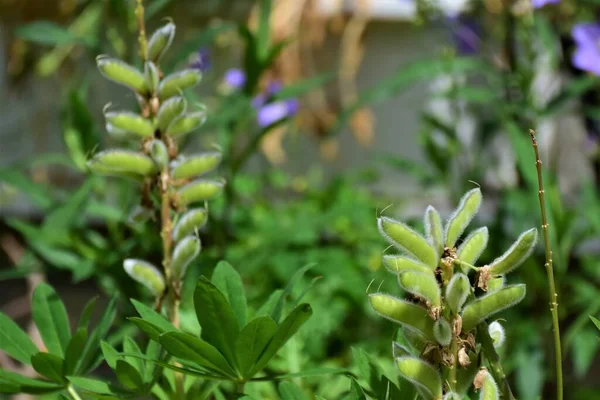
xmin=529 ymin=130 xmax=563 ymax=400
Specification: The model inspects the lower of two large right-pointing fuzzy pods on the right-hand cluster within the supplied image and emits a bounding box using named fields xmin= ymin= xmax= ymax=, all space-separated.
xmin=462 ymin=284 xmax=526 ymax=332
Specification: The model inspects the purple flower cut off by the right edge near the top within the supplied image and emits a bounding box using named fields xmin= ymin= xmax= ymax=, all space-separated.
xmin=571 ymin=22 xmax=600 ymax=75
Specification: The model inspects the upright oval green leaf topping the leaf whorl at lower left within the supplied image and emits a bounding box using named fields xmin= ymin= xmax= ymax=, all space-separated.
xmin=32 ymin=283 xmax=71 ymax=357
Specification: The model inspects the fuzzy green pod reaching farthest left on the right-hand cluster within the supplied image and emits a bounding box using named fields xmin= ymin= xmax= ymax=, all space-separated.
xmin=369 ymin=293 xmax=435 ymax=341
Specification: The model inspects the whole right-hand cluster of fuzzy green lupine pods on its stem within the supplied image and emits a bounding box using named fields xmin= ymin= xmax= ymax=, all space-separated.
xmin=370 ymin=189 xmax=537 ymax=400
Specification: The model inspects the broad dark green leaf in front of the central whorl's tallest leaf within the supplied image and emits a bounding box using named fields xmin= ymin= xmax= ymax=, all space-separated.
xmin=194 ymin=277 xmax=240 ymax=367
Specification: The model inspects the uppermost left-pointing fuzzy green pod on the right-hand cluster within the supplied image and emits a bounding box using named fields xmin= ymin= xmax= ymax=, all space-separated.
xmin=377 ymin=217 xmax=438 ymax=269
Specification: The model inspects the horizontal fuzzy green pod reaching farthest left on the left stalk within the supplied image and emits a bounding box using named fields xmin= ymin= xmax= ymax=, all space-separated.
xmin=87 ymin=150 xmax=157 ymax=177
